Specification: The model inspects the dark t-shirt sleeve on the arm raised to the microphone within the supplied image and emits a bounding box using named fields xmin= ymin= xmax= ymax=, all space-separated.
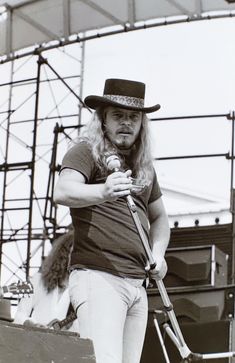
xmin=60 ymin=142 xmax=95 ymax=181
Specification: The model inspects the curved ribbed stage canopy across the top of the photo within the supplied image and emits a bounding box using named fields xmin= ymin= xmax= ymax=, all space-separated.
xmin=0 ymin=0 xmax=235 ymax=56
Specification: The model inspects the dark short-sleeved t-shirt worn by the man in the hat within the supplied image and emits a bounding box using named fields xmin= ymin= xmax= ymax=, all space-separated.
xmin=61 ymin=142 xmax=161 ymax=278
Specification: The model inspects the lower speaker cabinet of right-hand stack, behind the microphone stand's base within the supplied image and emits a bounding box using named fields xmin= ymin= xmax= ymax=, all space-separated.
xmin=141 ymin=285 xmax=235 ymax=363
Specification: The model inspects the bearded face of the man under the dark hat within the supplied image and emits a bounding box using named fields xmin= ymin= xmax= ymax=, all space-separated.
xmin=104 ymin=106 xmax=143 ymax=150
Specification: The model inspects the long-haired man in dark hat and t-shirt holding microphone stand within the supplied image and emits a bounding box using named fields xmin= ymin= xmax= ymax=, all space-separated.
xmin=55 ymin=79 xmax=170 ymax=363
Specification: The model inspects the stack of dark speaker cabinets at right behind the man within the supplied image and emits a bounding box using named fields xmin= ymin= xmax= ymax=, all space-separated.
xmin=141 ymin=225 xmax=235 ymax=363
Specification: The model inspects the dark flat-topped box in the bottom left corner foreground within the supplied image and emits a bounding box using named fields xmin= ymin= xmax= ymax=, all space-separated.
xmin=0 ymin=321 xmax=96 ymax=363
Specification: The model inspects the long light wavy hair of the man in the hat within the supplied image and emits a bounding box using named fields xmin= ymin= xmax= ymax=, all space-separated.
xmin=78 ymin=108 xmax=153 ymax=185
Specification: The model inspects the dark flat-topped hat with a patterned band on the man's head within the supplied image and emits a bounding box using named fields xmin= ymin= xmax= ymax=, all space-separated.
xmin=84 ymin=78 xmax=161 ymax=113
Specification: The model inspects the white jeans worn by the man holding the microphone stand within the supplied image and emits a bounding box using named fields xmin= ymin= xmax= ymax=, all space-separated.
xmin=69 ymin=270 xmax=148 ymax=363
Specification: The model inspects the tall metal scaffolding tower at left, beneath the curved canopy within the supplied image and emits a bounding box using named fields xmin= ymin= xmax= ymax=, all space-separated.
xmin=0 ymin=43 xmax=88 ymax=285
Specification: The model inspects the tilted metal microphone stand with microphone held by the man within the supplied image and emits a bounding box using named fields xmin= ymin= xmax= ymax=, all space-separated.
xmin=106 ymin=155 xmax=235 ymax=363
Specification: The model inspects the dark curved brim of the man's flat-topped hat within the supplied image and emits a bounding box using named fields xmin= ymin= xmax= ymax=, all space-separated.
xmin=84 ymin=95 xmax=161 ymax=113
